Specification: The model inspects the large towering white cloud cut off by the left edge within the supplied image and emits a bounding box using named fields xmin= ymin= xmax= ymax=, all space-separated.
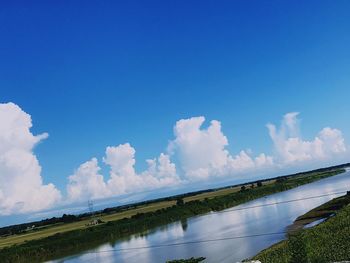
xmin=0 ymin=103 xmax=61 ymax=215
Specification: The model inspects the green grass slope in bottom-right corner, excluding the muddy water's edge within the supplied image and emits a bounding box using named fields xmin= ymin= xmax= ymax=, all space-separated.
xmin=254 ymin=197 xmax=350 ymax=263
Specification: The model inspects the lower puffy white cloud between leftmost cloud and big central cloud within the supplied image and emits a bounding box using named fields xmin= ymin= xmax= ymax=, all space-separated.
xmin=67 ymin=143 xmax=181 ymax=201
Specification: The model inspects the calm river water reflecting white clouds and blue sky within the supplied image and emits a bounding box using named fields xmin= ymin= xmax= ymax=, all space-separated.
xmin=56 ymin=172 xmax=350 ymax=263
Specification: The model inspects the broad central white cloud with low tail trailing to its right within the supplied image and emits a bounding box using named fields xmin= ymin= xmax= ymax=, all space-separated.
xmin=168 ymin=116 xmax=273 ymax=180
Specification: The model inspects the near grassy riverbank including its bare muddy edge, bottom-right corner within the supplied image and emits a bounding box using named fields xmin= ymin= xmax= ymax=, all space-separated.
xmin=253 ymin=195 xmax=350 ymax=263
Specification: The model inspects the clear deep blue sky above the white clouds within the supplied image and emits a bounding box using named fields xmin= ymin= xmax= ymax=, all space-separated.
xmin=0 ymin=0 xmax=350 ymax=224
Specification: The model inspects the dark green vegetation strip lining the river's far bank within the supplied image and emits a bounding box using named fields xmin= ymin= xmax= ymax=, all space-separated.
xmin=0 ymin=164 xmax=349 ymax=263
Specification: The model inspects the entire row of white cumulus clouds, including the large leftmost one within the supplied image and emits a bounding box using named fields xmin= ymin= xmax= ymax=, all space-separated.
xmin=0 ymin=103 xmax=348 ymax=215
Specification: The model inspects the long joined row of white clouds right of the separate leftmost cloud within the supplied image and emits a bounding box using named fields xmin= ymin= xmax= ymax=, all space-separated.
xmin=67 ymin=112 xmax=346 ymax=200
